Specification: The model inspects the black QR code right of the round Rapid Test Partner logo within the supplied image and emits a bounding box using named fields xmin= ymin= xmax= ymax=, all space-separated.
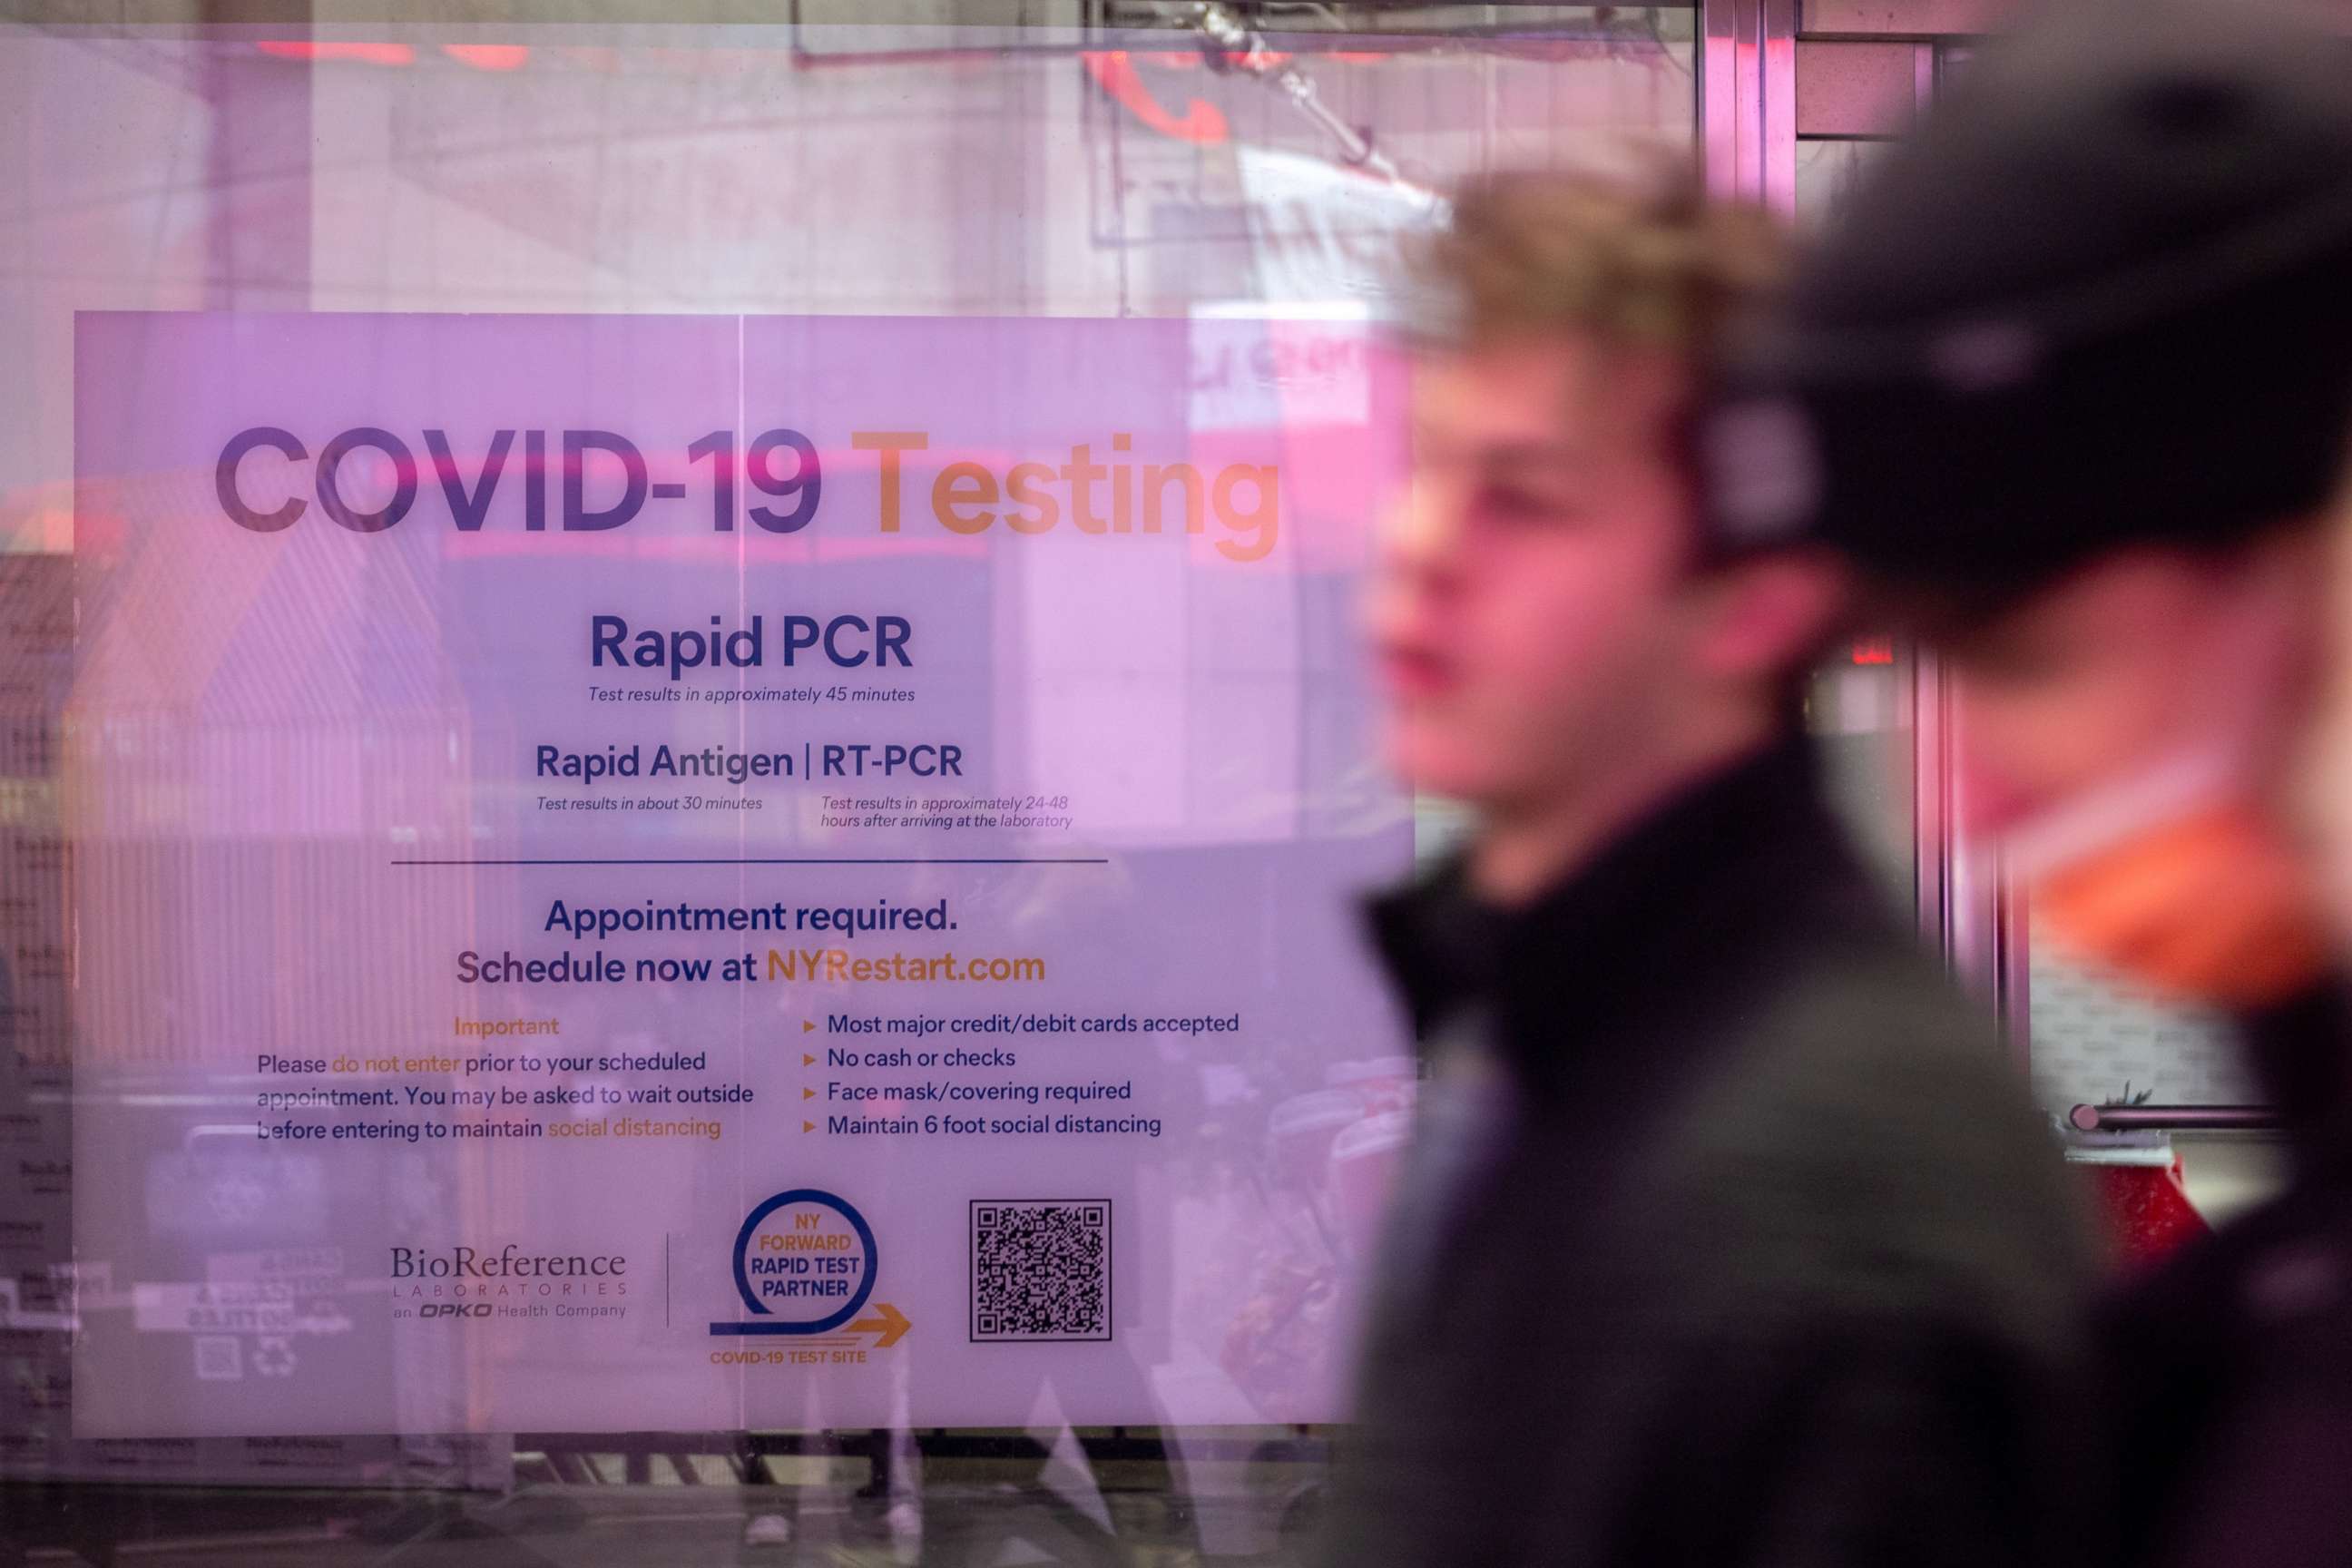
xmin=971 ymin=1199 xmax=1110 ymax=1340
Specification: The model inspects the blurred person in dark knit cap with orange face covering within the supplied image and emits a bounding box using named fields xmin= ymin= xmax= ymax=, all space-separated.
xmin=1696 ymin=0 xmax=2352 ymax=1565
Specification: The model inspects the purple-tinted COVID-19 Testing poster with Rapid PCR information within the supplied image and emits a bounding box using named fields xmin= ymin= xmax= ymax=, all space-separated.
xmin=66 ymin=315 xmax=1409 ymax=1436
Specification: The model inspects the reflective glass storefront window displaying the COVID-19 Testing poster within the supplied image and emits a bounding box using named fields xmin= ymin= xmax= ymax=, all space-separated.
xmin=0 ymin=5 xmax=1693 ymax=1563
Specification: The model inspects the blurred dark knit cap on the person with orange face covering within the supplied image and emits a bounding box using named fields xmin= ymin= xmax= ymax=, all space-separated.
xmin=1696 ymin=0 xmax=2352 ymax=600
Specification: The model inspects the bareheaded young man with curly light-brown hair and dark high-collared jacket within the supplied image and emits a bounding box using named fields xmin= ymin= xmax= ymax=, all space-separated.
xmin=1319 ymin=172 xmax=2095 ymax=1568
